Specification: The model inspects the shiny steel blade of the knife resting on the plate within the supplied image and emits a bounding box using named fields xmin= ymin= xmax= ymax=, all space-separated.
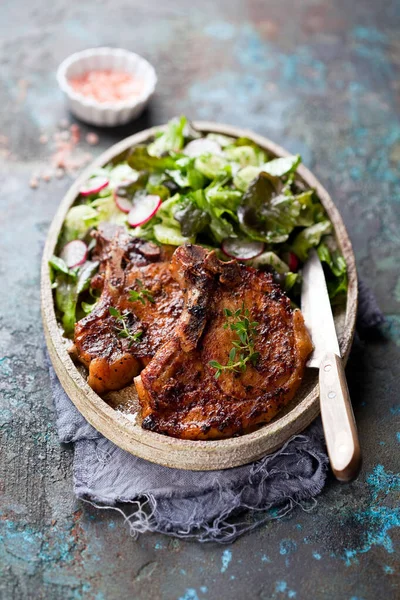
xmin=301 ymin=249 xmax=340 ymax=369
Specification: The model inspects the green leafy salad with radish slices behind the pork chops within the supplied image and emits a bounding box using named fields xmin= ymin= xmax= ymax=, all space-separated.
xmin=50 ymin=117 xmax=347 ymax=335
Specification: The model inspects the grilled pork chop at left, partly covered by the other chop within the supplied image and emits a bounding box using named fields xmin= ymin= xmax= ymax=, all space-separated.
xmin=72 ymin=224 xmax=183 ymax=394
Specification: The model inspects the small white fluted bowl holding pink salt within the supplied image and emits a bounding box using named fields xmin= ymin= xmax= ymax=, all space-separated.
xmin=57 ymin=48 xmax=157 ymax=127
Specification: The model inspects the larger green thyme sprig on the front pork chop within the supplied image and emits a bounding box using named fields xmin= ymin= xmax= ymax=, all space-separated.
xmin=208 ymin=302 xmax=260 ymax=379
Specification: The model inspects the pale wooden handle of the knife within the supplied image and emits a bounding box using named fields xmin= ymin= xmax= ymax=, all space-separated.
xmin=319 ymin=352 xmax=361 ymax=481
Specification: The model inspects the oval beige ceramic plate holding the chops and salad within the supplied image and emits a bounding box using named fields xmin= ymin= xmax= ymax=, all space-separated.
xmin=41 ymin=122 xmax=357 ymax=470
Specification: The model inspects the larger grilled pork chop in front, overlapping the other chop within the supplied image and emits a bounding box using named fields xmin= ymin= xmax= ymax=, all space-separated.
xmin=135 ymin=245 xmax=312 ymax=440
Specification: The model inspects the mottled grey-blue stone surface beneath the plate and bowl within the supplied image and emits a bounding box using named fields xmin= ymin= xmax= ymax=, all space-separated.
xmin=0 ymin=0 xmax=400 ymax=600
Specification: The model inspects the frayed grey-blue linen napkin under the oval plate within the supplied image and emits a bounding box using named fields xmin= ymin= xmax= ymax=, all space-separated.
xmin=50 ymin=285 xmax=383 ymax=542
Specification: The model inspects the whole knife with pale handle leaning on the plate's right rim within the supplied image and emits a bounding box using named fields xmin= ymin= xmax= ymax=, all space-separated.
xmin=301 ymin=249 xmax=361 ymax=481
